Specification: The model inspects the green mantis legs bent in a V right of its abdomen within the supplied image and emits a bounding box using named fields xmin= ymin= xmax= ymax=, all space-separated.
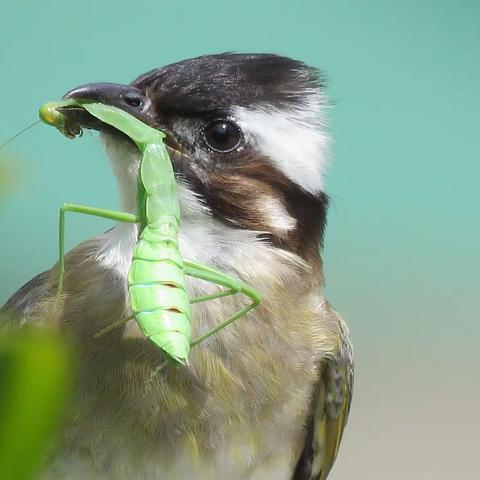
xmin=184 ymin=261 xmax=260 ymax=347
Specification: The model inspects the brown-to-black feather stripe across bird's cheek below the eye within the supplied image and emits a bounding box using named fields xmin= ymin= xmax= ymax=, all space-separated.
xmin=167 ymin=149 xmax=328 ymax=261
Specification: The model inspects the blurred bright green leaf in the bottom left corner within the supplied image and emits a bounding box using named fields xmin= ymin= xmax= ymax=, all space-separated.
xmin=0 ymin=312 xmax=72 ymax=480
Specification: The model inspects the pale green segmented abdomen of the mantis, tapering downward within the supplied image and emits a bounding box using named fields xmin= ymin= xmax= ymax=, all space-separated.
xmin=128 ymin=220 xmax=191 ymax=364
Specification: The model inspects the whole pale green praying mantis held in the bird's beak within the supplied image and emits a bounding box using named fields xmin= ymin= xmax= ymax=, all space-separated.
xmin=39 ymin=100 xmax=260 ymax=366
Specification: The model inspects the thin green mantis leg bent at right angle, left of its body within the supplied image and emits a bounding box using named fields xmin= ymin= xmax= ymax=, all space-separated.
xmin=57 ymin=203 xmax=140 ymax=297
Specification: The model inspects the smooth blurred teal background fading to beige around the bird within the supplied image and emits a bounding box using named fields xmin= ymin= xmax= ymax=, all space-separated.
xmin=0 ymin=0 xmax=480 ymax=480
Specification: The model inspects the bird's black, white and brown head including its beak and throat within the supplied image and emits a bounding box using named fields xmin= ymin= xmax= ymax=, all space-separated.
xmin=54 ymin=53 xmax=329 ymax=262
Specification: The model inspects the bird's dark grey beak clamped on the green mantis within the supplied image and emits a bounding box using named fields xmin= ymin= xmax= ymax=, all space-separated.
xmin=44 ymin=83 xmax=153 ymax=136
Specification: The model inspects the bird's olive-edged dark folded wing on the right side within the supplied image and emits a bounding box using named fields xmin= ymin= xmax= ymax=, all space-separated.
xmin=293 ymin=302 xmax=353 ymax=480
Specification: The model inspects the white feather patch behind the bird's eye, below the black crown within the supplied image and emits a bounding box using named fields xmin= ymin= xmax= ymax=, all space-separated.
xmin=234 ymin=95 xmax=330 ymax=194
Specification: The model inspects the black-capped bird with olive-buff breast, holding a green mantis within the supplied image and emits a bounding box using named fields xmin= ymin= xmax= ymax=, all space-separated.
xmin=3 ymin=52 xmax=353 ymax=480
